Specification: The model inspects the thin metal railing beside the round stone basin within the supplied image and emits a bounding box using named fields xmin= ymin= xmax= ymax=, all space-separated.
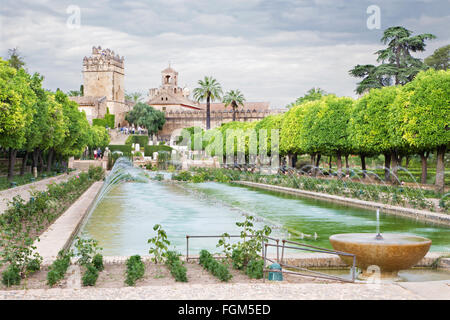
xmin=186 ymin=235 xmax=356 ymax=282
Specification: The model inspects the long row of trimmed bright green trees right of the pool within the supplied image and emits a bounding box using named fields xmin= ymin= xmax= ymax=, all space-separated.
xmin=189 ymin=69 xmax=450 ymax=190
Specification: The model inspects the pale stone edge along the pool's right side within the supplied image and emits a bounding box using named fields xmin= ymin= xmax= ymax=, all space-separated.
xmin=232 ymin=181 xmax=450 ymax=226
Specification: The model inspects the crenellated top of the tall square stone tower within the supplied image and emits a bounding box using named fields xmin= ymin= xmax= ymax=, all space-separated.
xmin=83 ymin=46 xmax=124 ymax=72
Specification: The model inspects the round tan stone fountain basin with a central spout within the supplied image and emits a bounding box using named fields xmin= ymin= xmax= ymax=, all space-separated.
xmin=330 ymin=233 xmax=431 ymax=278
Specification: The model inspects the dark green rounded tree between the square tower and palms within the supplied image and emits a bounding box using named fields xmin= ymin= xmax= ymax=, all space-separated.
xmin=125 ymin=102 xmax=166 ymax=135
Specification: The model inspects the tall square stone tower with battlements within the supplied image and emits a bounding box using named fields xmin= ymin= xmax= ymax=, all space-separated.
xmin=83 ymin=46 xmax=128 ymax=126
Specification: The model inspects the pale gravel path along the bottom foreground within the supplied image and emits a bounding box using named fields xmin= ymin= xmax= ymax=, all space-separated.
xmin=0 ymin=282 xmax=424 ymax=300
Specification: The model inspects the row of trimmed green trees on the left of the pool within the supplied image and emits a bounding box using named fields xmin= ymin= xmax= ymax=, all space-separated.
xmin=0 ymin=58 xmax=109 ymax=181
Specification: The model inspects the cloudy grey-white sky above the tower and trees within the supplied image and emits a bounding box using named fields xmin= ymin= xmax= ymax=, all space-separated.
xmin=0 ymin=0 xmax=450 ymax=108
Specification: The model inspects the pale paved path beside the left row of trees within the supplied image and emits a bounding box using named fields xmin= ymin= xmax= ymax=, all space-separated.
xmin=0 ymin=171 xmax=79 ymax=214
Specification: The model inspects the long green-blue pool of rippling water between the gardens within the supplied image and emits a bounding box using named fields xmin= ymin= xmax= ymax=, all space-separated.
xmin=81 ymin=181 xmax=450 ymax=255
